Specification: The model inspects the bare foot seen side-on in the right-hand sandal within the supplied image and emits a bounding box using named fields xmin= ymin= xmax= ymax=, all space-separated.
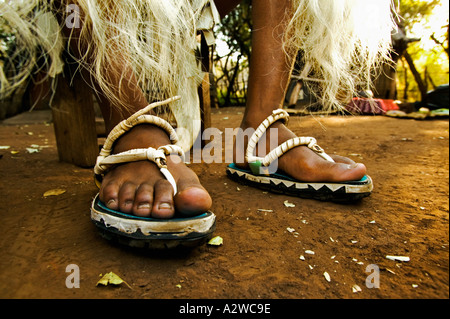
xmin=235 ymin=121 xmax=366 ymax=182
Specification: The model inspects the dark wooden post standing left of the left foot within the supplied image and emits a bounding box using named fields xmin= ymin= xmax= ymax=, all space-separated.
xmin=52 ymin=72 xmax=99 ymax=167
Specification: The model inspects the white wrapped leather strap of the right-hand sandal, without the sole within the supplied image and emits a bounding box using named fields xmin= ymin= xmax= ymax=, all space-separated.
xmin=245 ymin=109 xmax=334 ymax=166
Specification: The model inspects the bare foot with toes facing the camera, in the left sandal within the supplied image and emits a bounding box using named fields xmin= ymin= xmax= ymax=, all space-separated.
xmin=99 ymin=125 xmax=212 ymax=218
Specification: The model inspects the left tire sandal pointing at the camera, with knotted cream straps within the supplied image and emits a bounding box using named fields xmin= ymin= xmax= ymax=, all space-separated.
xmin=91 ymin=97 xmax=216 ymax=249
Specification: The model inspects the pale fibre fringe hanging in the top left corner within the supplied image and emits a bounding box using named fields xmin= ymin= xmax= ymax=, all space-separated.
xmin=0 ymin=0 xmax=64 ymax=99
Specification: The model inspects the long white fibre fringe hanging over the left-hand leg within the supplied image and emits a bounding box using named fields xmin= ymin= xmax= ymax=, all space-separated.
xmin=71 ymin=0 xmax=207 ymax=151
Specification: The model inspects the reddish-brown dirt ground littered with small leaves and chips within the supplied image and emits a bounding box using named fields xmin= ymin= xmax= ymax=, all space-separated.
xmin=0 ymin=108 xmax=449 ymax=299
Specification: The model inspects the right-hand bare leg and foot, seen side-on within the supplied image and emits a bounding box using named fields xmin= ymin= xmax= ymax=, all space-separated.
xmin=236 ymin=0 xmax=366 ymax=182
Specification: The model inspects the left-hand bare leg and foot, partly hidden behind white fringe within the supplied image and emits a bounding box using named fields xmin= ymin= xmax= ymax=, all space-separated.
xmin=60 ymin=1 xmax=211 ymax=218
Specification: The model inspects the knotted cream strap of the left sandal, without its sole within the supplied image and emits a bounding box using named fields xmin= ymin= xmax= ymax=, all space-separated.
xmin=94 ymin=96 xmax=184 ymax=194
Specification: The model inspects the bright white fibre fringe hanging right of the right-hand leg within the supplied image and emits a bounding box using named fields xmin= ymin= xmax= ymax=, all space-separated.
xmin=284 ymin=0 xmax=396 ymax=110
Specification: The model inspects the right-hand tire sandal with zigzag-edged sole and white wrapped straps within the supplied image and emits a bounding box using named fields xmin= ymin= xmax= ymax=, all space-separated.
xmin=227 ymin=109 xmax=373 ymax=202
